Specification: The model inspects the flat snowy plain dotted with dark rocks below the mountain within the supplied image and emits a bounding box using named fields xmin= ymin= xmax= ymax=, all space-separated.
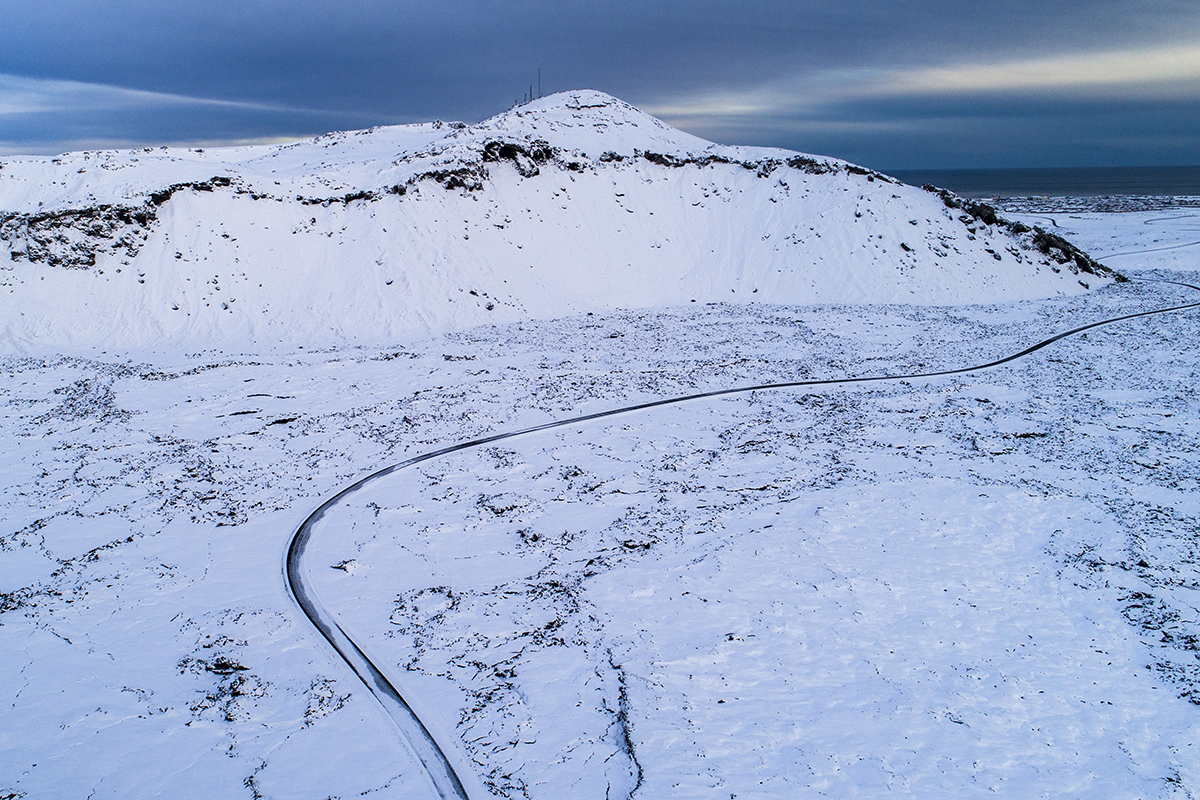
xmin=0 ymin=211 xmax=1200 ymax=800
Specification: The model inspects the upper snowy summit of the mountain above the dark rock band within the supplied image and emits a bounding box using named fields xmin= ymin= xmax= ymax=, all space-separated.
xmin=0 ymin=90 xmax=796 ymax=213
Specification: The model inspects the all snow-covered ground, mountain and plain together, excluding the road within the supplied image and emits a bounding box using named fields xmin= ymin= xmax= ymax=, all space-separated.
xmin=0 ymin=92 xmax=1200 ymax=800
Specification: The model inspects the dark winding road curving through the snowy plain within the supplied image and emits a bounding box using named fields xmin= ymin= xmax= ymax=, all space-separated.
xmin=284 ymin=278 xmax=1200 ymax=800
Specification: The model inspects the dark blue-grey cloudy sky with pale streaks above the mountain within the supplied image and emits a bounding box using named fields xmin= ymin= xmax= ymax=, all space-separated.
xmin=0 ymin=0 xmax=1200 ymax=169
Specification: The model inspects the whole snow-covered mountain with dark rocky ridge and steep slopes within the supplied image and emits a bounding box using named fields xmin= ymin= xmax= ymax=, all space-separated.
xmin=0 ymin=91 xmax=1111 ymax=351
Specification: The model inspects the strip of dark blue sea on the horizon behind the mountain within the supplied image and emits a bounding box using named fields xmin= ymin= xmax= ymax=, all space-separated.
xmin=888 ymin=167 xmax=1200 ymax=197
